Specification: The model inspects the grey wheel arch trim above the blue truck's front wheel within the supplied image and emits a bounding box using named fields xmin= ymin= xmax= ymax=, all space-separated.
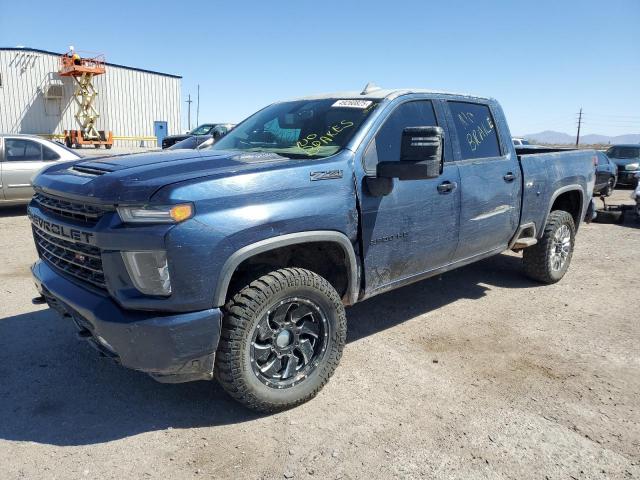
xmin=213 ymin=230 xmax=360 ymax=306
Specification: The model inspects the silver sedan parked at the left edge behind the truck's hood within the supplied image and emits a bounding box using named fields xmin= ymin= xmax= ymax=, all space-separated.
xmin=0 ymin=134 xmax=82 ymax=205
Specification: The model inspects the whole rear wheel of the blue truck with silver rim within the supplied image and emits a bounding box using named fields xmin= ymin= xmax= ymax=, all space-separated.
xmin=522 ymin=210 xmax=576 ymax=283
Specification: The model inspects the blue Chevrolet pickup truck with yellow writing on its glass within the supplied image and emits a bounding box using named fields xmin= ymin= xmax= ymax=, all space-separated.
xmin=28 ymin=88 xmax=595 ymax=411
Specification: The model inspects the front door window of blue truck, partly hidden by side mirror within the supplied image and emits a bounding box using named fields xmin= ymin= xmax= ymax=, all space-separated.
xmin=365 ymin=100 xmax=438 ymax=170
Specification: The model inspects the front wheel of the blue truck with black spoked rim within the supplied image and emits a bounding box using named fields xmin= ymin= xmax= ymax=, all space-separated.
xmin=215 ymin=268 xmax=347 ymax=412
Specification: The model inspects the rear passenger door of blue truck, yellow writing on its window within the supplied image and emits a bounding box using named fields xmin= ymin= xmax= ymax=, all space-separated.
xmin=446 ymin=101 xmax=522 ymax=260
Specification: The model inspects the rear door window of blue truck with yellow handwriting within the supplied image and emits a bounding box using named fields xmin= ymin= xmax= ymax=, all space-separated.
xmin=448 ymin=102 xmax=500 ymax=160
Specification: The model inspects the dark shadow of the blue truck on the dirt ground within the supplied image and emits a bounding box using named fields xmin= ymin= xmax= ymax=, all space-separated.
xmin=0 ymin=255 xmax=536 ymax=446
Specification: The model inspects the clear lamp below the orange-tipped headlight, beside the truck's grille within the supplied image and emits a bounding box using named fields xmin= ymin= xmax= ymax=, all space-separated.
xmin=122 ymin=250 xmax=171 ymax=296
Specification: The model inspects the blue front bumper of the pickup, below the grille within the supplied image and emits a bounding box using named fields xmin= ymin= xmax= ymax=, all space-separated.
xmin=31 ymin=260 xmax=222 ymax=383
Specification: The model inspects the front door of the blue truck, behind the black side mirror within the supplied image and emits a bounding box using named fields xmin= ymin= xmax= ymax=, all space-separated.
xmin=358 ymin=99 xmax=460 ymax=295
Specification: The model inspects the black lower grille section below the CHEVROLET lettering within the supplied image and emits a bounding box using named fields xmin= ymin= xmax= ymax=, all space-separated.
xmin=32 ymin=225 xmax=106 ymax=288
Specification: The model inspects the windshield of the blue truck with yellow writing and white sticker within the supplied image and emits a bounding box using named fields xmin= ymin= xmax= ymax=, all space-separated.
xmin=211 ymin=98 xmax=379 ymax=158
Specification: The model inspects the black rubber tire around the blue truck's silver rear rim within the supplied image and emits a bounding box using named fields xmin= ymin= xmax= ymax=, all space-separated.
xmin=522 ymin=210 xmax=576 ymax=284
